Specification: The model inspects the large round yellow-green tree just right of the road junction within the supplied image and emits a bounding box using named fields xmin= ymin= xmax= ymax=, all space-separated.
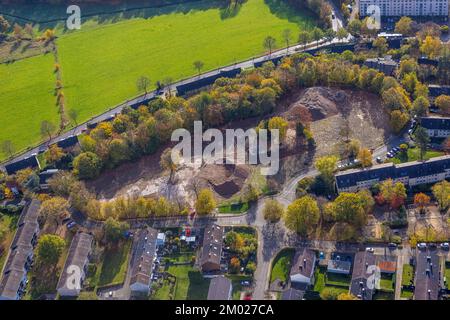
xmin=284 ymin=196 xmax=320 ymax=236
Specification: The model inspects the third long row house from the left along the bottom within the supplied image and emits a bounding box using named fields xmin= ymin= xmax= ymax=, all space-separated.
xmin=130 ymin=228 xmax=158 ymax=295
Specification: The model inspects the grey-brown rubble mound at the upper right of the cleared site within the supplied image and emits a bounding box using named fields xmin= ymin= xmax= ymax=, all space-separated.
xmin=284 ymin=87 xmax=349 ymax=121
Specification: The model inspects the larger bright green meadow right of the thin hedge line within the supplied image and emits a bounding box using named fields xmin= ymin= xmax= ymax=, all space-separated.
xmin=57 ymin=0 xmax=315 ymax=121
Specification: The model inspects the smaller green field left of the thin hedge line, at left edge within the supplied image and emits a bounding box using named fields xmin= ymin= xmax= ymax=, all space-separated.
xmin=0 ymin=54 xmax=60 ymax=160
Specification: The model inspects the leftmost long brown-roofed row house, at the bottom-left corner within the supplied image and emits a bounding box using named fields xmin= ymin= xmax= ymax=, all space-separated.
xmin=0 ymin=200 xmax=41 ymax=300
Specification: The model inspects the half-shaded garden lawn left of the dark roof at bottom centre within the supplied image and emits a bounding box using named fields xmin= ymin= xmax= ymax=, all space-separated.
xmin=167 ymin=265 xmax=210 ymax=300
